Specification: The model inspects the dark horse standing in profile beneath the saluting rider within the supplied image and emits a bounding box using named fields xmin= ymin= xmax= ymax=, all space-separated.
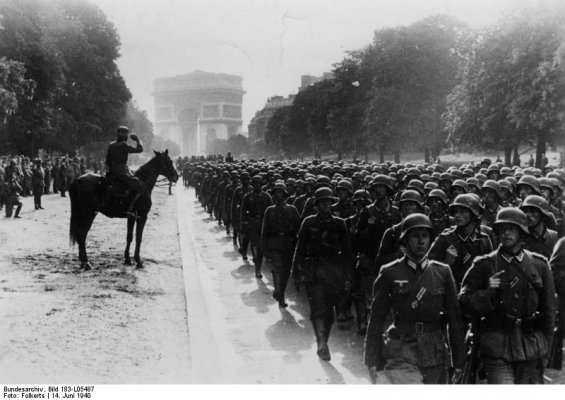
xmin=69 ymin=150 xmax=178 ymax=270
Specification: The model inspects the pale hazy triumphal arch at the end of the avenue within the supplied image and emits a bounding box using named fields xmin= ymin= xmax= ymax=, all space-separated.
xmin=153 ymin=71 xmax=245 ymax=155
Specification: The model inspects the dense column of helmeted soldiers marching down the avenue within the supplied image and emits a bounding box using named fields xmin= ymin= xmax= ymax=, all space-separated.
xmin=177 ymin=158 xmax=565 ymax=384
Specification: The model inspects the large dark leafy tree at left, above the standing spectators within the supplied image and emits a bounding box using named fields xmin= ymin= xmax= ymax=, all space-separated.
xmin=0 ymin=0 xmax=131 ymax=154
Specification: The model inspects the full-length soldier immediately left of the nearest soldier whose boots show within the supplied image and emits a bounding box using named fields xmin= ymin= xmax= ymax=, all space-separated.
xmin=261 ymin=182 xmax=300 ymax=308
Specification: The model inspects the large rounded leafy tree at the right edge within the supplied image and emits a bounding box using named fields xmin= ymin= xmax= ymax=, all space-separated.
xmin=444 ymin=5 xmax=565 ymax=165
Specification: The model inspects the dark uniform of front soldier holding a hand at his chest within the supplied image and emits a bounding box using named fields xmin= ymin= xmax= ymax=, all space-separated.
xmin=459 ymin=249 xmax=555 ymax=384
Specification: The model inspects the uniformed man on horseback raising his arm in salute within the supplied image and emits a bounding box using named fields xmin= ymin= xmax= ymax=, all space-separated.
xmin=106 ymin=126 xmax=145 ymax=218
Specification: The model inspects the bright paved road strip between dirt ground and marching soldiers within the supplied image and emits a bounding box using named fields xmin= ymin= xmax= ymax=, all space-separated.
xmin=176 ymin=186 xmax=369 ymax=384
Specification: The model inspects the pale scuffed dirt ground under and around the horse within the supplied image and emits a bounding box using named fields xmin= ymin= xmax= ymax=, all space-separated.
xmin=0 ymin=189 xmax=192 ymax=384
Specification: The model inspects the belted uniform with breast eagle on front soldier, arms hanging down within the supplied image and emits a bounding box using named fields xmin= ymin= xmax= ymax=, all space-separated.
xmin=365 ymin=256 xmax=465 ymax=384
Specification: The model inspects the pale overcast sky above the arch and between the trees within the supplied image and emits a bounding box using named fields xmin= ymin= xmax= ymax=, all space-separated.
xmin=91 ymin=0 xmax=559 ymax=132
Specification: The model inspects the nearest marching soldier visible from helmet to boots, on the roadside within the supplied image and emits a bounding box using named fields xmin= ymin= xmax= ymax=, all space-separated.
xmin=292 ymin=188 xmax=353 ymax=361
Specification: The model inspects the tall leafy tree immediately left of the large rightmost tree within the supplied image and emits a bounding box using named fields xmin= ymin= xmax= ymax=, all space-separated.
xmin=362 ymin=16 xmax=468 ymax=161
